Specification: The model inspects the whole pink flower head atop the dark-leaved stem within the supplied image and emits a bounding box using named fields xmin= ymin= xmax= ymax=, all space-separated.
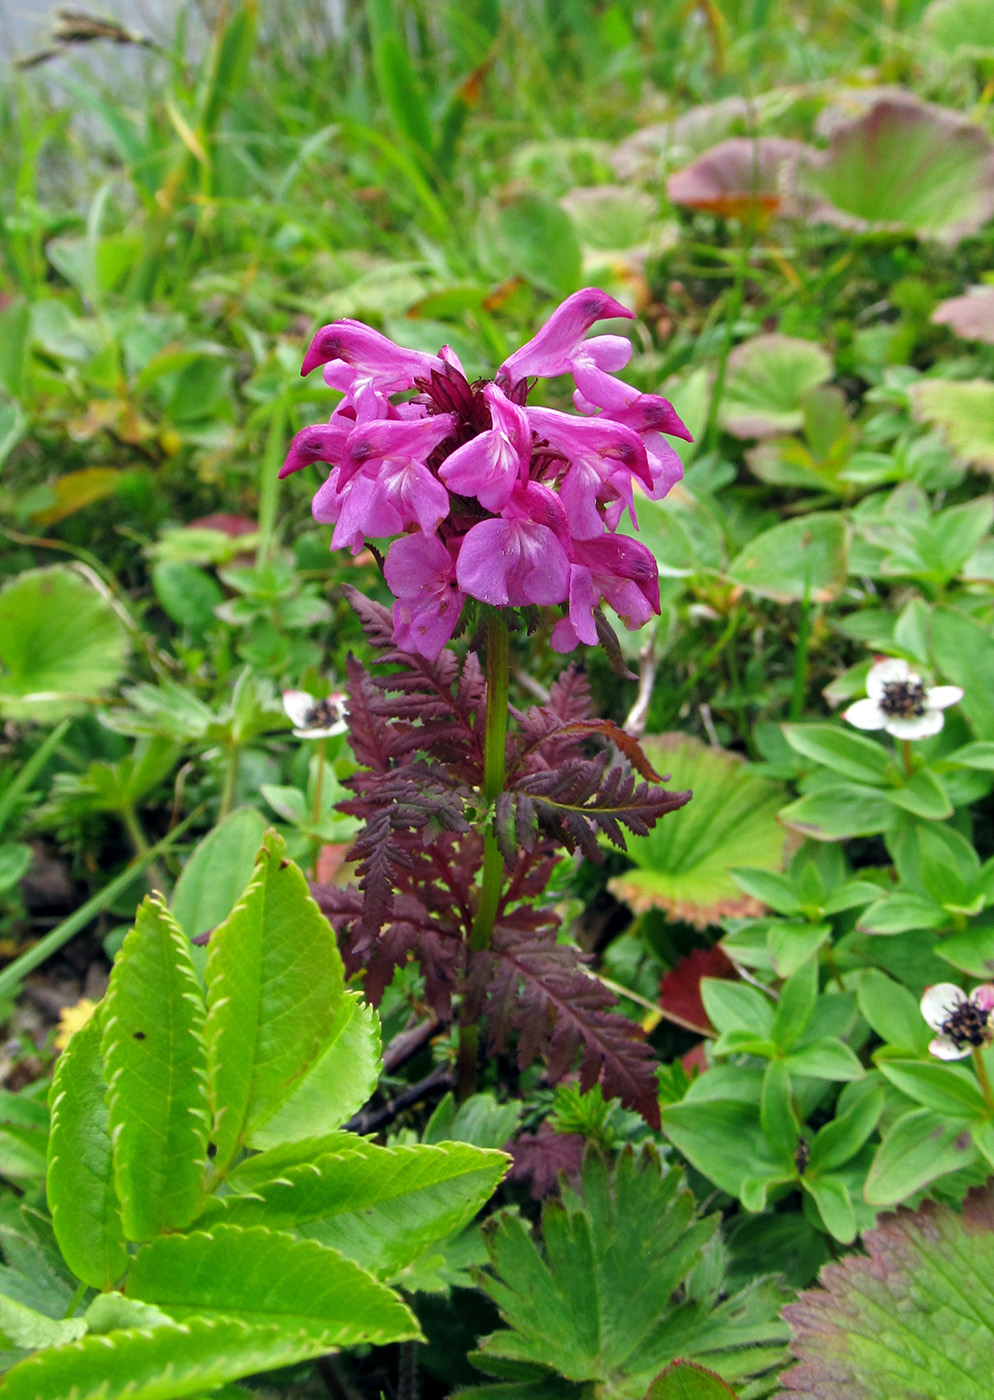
xmin=280 ymin=288 xmax=690 ymax=659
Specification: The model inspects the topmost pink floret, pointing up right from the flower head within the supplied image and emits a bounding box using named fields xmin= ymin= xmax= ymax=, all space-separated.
xmin=498 ymin=287 xmax=631 ymax=409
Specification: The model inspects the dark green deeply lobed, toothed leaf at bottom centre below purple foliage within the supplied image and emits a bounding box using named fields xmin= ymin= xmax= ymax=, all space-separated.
xmin=466 ymin=1148 xmax=784 ymax=1397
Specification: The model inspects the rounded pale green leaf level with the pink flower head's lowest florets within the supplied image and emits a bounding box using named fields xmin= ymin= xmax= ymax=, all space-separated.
xmin=725 ymin=511 xmax=847 ymax=603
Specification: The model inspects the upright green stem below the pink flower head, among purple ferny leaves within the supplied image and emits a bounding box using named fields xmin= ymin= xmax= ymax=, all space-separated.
xmin=458 ymin=612 xmax=511 ymax=1103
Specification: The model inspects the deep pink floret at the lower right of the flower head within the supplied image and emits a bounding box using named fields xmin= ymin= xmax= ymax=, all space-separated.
xmin=552 ymin=535 xmax=659 ymax=651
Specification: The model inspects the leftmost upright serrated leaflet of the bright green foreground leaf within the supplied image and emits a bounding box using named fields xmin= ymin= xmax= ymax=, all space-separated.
xmin=46 ymin=1015 xmax=127 ymax=1288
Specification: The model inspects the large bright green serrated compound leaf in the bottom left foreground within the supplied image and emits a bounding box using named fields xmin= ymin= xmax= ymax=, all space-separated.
xmin=0 ymin=833 xmax=507 ymax=1400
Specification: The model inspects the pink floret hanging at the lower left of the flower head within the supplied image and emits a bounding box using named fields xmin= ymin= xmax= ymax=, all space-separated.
xmin=384 ymin=535 xmax=465 ymax=661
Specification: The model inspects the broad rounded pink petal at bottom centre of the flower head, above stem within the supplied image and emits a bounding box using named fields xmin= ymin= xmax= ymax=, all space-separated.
xmin=456 ymin=519 xmax=570 ymax=608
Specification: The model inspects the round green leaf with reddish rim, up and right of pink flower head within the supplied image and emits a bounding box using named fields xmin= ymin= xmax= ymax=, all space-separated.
xmin=721 ymin=332 xmax=832 ymax=436
